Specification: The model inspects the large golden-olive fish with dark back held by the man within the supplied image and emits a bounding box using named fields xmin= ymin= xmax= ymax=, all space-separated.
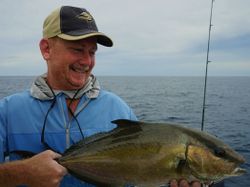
xmin=58 ymin=119 xmax=246 ymax=187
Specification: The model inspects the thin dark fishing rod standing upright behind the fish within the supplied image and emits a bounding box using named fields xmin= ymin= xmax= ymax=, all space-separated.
xmin=201 ymin=0 xmax=214 ymax=131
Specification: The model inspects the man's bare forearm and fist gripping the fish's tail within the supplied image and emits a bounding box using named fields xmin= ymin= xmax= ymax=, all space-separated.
xmin=0 ymin=150 xmax=67 ymax=187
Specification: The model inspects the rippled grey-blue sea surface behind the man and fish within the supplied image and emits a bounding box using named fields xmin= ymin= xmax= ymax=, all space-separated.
xmin=0 ymin=76 xmax=250 ymax=187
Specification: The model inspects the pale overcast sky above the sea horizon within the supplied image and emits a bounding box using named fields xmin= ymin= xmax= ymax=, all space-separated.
xmin=0 ymin=0 xmax=250 ymax=76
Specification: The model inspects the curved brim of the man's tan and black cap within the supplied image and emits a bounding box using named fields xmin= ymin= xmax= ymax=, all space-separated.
xmin=57 ymin=32 xmax=113 ymax=47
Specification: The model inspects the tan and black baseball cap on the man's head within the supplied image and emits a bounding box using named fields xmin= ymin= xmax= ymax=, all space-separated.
xmin=43 ymin=6 xmax=113 ymax=47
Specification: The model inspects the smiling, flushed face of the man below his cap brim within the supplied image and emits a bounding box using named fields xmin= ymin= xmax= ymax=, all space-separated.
xmin=43 ymin=38 xmax=97 ymax=90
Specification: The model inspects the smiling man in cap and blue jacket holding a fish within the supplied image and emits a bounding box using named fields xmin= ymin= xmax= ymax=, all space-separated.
xmin=0 ymin=6 xmax=202 ymax=187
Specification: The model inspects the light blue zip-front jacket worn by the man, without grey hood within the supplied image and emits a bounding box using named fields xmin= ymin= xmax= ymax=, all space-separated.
xmin=0 ymin=90 xmax=136 ymax=187
